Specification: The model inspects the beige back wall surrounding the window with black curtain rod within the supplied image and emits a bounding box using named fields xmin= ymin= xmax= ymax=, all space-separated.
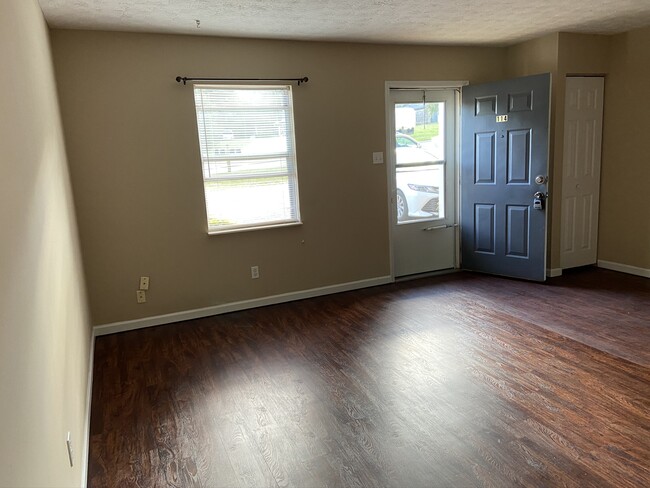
xmin=52 ymin=30 xmax=505 ymax=324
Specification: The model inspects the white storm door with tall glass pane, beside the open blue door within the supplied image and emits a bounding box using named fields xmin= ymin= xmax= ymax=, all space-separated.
xmin=388 ymin=89 xmax=457 ymax=277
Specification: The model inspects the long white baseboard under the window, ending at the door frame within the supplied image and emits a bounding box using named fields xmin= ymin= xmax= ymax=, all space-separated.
xmin=93 ymin=276 xmax=393 ymax=336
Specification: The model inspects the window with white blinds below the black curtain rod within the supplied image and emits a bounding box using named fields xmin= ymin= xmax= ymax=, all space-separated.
xmin=194 ymin=85 xmax=300 ymax=233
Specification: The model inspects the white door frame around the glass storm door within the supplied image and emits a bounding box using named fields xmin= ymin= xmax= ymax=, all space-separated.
xmin=384 ymin=80 xmax=469 ymax=282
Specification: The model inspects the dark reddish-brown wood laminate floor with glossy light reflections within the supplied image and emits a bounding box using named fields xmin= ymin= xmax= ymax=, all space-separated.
xmin=88 ymin=270 xmax=650 ymax=488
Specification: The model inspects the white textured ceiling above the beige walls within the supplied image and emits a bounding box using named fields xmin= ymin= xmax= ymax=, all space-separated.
xmin=39 ymin=0 xmax=650 ymax=46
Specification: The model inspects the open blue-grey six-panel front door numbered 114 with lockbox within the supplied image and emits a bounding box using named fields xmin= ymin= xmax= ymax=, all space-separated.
xmin=460 ymin=74 xmax=550 ymax=281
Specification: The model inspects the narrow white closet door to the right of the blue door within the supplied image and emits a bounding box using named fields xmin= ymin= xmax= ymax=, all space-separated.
xmin=560 ymin=77 xmax=605 ymax=269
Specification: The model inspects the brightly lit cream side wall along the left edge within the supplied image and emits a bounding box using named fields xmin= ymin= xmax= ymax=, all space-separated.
xmin=0 ymin=0 xmax=90 ymax=488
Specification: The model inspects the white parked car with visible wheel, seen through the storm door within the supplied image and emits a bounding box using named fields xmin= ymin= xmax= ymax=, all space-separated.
xmin=395 ymin=132 xmax=442 ymax=222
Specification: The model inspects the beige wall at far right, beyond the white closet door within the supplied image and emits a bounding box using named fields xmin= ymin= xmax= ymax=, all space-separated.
xmin=598 ymin=27 xmax=650 ymax=270
